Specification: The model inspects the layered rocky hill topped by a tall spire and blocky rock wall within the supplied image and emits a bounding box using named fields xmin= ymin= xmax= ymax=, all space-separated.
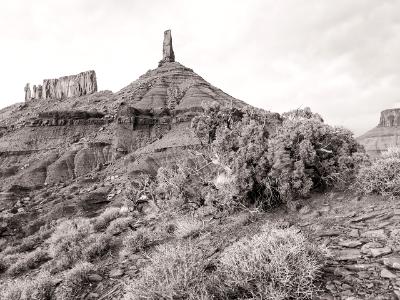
xmin=0 ymin=31 xmax=245 ymax=207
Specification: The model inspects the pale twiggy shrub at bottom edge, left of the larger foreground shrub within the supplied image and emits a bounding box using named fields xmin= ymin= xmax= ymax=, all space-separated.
xmin=124 ymin=243 xmax=207 ymax=300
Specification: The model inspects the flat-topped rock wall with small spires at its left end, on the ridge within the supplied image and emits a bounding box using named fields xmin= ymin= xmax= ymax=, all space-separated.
xmin=24 ymin=70 xmax=97 ymax=101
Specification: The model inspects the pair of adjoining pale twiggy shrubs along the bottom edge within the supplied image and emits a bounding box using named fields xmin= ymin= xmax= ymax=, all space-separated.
xmin=125 ymin=226 xmax=325 ymax=300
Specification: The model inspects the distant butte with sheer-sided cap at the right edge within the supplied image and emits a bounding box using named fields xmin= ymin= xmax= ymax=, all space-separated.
xmin=357 ymin=109 xmax=400 ymax=156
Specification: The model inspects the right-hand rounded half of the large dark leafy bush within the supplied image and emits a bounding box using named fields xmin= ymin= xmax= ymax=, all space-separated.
xmin=268 ymin=109 xmax=366 ymax=202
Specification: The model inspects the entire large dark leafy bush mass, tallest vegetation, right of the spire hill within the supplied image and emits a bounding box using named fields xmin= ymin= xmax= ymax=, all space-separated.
xmin=192 ymin=106 xmax=365 ymax=207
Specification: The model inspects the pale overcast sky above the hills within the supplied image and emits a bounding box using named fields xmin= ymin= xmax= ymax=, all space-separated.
xmin=0 ymin=0 xmax=400 ymax=135
